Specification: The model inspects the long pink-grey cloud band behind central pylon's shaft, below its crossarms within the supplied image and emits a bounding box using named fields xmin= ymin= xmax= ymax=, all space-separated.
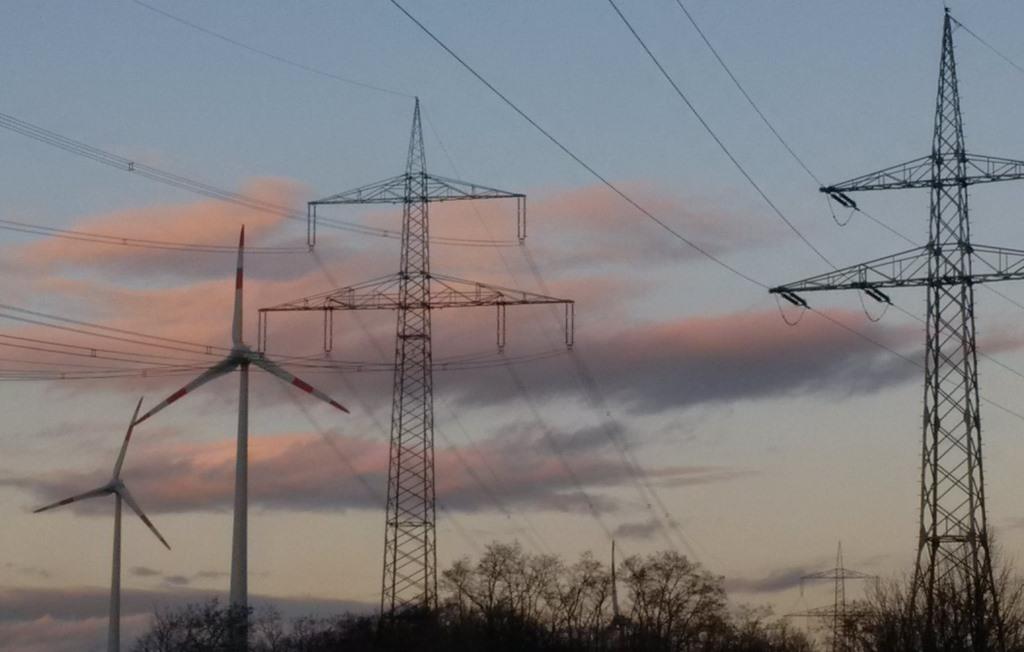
xmin=18 ymin=423 xmax=740 ymax=517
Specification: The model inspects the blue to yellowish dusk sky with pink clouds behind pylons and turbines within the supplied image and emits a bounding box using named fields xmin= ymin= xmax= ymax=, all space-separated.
xmin=0 ymin=0 xmax=1024 ymax=651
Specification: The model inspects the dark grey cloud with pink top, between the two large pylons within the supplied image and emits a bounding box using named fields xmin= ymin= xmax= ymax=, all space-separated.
xmin=453 ymin=310 xmax=921 ymax=414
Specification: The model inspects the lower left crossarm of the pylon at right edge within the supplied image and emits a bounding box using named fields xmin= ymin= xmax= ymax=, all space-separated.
xmin=768 ymin=247 xmax=929 ymax=301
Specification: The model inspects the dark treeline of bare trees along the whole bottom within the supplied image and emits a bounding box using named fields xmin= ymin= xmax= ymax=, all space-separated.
xmin=133 ymin=542 xmax=1024 ymax=652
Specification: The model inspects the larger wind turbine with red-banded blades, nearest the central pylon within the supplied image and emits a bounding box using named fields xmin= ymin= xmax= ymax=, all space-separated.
xmin=135 ymin=226 xmax=348 ymax=609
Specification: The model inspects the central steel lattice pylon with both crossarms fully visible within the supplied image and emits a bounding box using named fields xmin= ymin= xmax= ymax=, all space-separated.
xmin=260 ymin=98 xmax=573 ymax=616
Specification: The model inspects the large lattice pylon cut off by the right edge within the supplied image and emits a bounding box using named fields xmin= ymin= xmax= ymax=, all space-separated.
xmin=770 ymin=9 xmax=1024 ymax=651
